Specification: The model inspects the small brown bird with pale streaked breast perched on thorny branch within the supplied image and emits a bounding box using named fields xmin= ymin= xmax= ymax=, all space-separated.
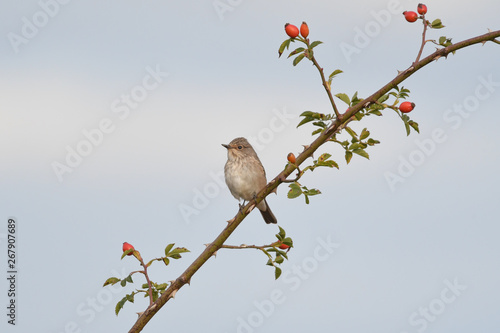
xmin=222 ymin=138 xmax=278 ymax=223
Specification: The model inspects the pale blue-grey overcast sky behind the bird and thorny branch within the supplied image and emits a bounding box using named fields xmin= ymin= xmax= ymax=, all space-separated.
xmin=0 ymin=0 xmax=500 ymax=333
